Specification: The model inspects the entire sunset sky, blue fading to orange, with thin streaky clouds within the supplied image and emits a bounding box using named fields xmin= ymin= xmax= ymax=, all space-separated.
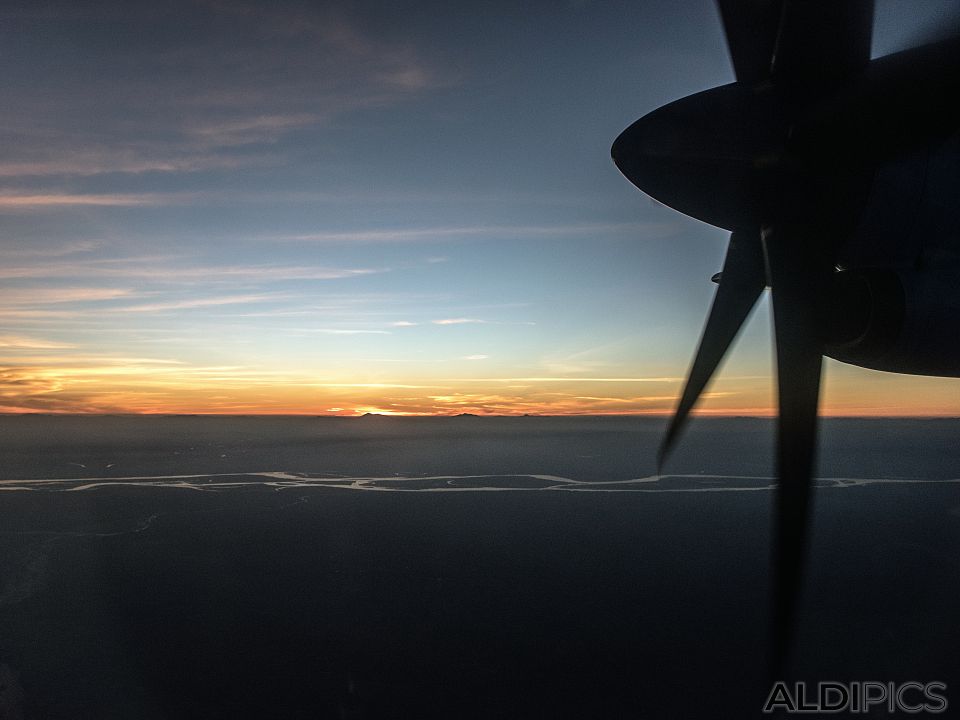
xmin=0 ymin=0 xmax=960 ymax=415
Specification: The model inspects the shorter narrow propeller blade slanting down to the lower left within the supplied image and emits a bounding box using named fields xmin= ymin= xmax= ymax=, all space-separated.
xmin=657 ymin=231 xmax=766 ymax=473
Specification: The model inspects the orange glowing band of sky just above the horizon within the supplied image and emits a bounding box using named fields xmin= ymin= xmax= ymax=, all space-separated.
xmin=0 ymin=358 xmax=960 ymax=417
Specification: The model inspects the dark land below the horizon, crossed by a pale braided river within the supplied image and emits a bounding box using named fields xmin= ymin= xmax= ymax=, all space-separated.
xmin=0 ymin=415 xmax=960 ymax=720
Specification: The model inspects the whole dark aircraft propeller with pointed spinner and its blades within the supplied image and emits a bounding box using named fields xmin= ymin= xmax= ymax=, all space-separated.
xmin=611 ymin=0 xmax=873 ymax=675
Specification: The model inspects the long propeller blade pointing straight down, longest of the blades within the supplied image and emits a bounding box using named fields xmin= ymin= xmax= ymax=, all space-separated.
xmin=764 ymin=228 xmax=830 ymax=673
